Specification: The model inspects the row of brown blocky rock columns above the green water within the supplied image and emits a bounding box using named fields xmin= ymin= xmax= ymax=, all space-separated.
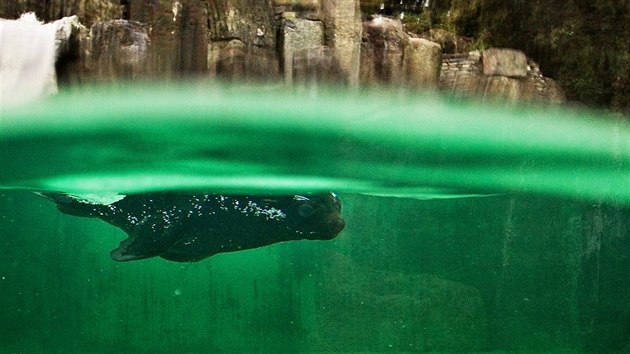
xmin=0 ymin=0 xmax=564 ymax=103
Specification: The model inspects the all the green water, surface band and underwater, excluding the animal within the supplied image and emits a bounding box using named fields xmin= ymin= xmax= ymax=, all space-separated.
xmin=0 ymin=85 xmax=630 ymax=353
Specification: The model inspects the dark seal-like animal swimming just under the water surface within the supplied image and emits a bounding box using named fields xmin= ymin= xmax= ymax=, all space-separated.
xmin=41 ymin=192 xmax=345 ymax=262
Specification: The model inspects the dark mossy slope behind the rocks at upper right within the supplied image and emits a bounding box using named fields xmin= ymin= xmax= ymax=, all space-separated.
xmin=362 ymin=0 xmax=630 ymax=113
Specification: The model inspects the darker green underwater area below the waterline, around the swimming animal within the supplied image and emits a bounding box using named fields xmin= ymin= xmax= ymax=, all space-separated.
xmin=0 ymin=191 xmax=630 ymax=352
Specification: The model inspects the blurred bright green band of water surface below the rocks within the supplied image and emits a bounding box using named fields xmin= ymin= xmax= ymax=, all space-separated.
xmin=0 ymin=85 xmax=630 ymax=199
